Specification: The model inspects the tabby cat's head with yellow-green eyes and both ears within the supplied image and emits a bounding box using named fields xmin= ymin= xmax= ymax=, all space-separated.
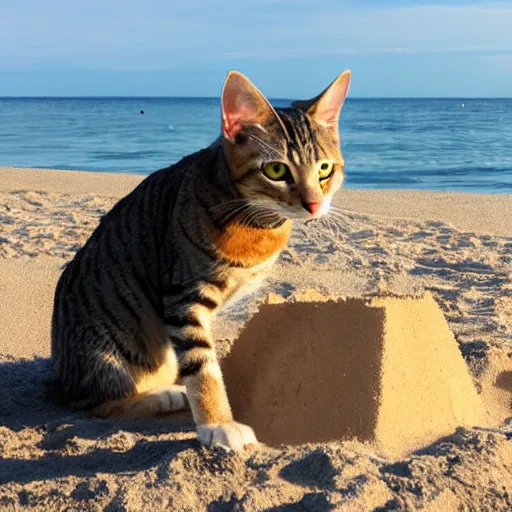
xmin=222 ymin=70 xmax=350 ymax=219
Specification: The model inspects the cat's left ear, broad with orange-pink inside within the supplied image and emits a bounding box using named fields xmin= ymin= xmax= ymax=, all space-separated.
xmin=221 ymin=71 xmax=276 ymax=141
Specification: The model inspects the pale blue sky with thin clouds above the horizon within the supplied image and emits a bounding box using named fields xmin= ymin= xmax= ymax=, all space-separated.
xmin=0 ymin=0 xmax=512 ymax=99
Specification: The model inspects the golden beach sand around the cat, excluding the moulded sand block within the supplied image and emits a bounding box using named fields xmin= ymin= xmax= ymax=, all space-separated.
xmin=0 ymin=167 xmax=512 ymax=511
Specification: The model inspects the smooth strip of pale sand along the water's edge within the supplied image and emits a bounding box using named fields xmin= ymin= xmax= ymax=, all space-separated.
xmin=4 ymin=166 xmax=512 ymax=237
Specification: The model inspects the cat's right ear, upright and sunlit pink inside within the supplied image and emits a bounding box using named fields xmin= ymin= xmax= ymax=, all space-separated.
xmin=292 ymin=69 xmax=351 ymax=131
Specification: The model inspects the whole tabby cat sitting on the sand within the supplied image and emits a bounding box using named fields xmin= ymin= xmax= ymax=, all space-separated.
xmin=52 ymin=70 xmax=350 ymax=450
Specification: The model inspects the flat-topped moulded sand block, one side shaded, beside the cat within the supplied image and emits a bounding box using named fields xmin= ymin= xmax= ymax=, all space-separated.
xmin=223 ymin=293 xmax=484 ymax=456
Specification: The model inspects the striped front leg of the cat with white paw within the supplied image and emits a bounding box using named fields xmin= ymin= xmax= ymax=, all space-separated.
xmin=164 ymin=297 xmax=258 ymax=451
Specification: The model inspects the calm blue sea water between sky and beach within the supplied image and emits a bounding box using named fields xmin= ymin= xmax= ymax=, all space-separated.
xmin=0 ymin=98 xmax=512 ymax=193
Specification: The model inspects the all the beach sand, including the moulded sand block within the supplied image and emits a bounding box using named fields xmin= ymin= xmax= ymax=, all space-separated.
xmin=0 ymin=167 xmax=512 ymax=511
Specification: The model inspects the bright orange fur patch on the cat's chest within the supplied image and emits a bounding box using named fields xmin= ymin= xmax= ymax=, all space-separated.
xmin=215 ymin=220 xmax=292 ymax=267
